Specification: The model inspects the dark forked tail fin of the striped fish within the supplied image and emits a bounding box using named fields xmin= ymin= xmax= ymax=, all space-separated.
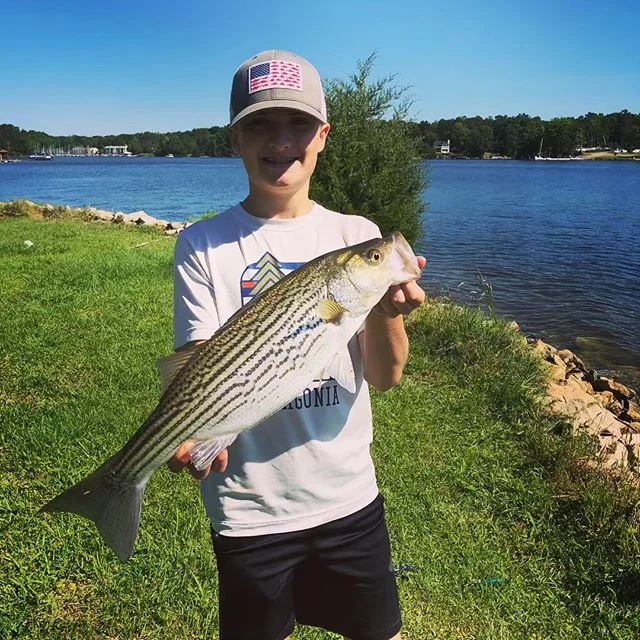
xmin=40 ymin=455 xmax=147 ymax=562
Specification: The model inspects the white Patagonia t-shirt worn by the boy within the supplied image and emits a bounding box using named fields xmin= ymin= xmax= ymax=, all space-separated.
xmin=174 ymin=204 xmax=380 ymax=536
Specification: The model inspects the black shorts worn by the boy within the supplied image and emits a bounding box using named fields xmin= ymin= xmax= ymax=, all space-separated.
xmin=213 ymin=495 xmax=400 ymax=640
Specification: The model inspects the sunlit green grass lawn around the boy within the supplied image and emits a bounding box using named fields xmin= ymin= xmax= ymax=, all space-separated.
xmin=0 ymin=214 xmax=640 ymax=640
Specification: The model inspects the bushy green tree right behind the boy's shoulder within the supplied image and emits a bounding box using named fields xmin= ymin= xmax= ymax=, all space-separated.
xmin=311 ymin=54 xmax=426 ymax=244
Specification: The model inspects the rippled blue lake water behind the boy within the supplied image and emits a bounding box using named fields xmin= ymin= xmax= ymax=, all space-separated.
xmin=0 ymin=158 xmax=640 ymax=388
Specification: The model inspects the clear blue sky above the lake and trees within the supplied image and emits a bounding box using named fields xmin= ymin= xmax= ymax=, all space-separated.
xmin=0 ymin=0 xmax=640 ymax=135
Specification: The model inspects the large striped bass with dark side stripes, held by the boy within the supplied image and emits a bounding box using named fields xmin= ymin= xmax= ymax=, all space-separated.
xmin=41 ymin=233 xmax=420 ymax=562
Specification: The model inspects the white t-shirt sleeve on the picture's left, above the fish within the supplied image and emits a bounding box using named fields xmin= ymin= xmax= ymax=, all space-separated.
xmin=173 ymin=232 xmax=220 ymax=349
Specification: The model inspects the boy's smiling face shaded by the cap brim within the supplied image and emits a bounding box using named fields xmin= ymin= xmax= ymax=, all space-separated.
xmin=231 ymin=108 xmax=331 ymax=193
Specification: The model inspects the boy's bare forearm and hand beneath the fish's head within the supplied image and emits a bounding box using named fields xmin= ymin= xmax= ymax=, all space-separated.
xmin=358 ymin=256 xmax=426 ymax=391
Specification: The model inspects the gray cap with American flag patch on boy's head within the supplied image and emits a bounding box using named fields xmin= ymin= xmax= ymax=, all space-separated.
xmin=229 ymin=49 xmax=327 ymax=125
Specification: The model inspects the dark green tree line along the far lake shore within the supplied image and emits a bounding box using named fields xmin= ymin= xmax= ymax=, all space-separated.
xmin=0 ymin=109 xmax=640 ymax=159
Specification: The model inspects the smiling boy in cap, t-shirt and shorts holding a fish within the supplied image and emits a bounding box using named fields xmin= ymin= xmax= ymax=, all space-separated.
xmin=169 ymin=50 xmax=424 ymax=640
